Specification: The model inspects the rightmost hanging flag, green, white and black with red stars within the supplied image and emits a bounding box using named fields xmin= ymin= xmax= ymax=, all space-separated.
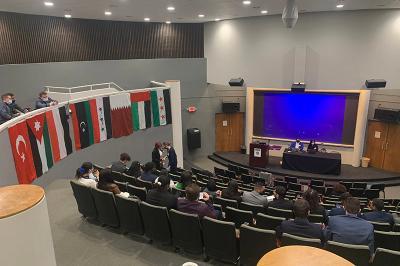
xmin=150 ymin=89 xmax=172 ymax=127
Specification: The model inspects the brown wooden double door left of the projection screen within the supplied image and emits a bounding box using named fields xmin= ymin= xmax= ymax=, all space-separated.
xmin=215 ymin=112 xmax=244 ymax=152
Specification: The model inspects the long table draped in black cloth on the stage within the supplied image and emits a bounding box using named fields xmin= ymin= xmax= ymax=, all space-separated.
xmin=282 ymin=151 xmax=342 ymax=175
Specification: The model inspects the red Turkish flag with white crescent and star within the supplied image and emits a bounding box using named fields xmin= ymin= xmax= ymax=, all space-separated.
xmin=8 ymin=121 xmax=36 ymax=184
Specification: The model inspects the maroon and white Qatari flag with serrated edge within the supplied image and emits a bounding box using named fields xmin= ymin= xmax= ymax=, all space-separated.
xmin=110 ymin=93 xmax=133 ymax=138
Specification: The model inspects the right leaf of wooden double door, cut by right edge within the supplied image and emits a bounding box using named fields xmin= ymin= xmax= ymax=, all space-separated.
xmin=383 ymin=124 xmax=400 ymax=172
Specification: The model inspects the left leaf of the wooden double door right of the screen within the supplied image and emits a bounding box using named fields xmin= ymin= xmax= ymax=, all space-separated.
xmin=365 ymin=121 xmax=388 ymax=168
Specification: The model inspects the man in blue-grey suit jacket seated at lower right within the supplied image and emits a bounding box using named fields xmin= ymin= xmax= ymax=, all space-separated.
xmin=326 ymin=197 xmax=375 ymax=254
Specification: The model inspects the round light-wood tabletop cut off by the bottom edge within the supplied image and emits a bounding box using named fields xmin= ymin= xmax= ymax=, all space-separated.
xmin=257 ymin=246 xmax=354 ymax=266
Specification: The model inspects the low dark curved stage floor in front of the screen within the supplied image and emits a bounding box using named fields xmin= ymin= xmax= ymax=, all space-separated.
xmin=208 ymin=152 xmax=400 ymax=186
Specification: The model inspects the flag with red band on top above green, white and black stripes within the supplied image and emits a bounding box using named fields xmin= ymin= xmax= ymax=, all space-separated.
xmin=131 ymin=91 xmax=151 ymax=131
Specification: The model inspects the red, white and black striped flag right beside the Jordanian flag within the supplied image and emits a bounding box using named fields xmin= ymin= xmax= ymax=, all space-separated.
xmin=45 ymin=106 xmax=72 ymax=163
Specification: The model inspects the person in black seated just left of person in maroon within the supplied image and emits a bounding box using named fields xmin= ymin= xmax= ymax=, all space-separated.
xmin=146 ymin=175 xmax=178 ymax=209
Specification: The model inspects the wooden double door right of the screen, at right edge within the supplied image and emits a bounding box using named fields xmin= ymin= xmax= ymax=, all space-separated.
xmin=365 ymin=121 xmax=400 ymax=172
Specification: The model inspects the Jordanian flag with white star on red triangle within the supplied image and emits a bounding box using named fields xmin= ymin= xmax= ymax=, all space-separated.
xmin=26 ymin=113 xmax=53 ymax=177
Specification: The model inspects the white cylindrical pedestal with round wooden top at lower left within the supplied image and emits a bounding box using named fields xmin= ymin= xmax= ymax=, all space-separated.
xmin=0 ymin=185 xmax=56 ymax=266
